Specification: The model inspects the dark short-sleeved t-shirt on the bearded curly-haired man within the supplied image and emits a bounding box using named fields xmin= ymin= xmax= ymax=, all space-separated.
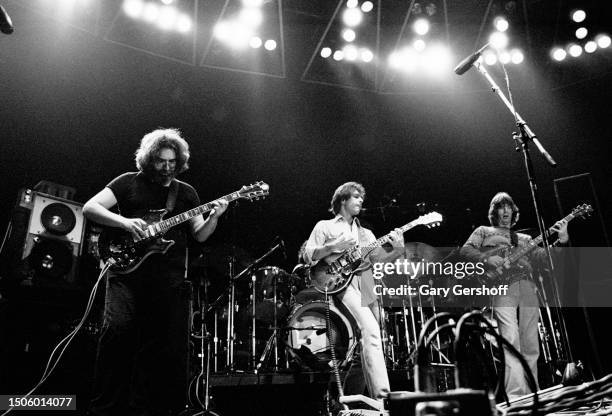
xmin=106 ymin=172 xmax=200 ymax=268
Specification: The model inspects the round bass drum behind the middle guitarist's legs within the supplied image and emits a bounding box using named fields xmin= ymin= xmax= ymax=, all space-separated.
xmin=287 ymin=301 xmax=357 ymax=370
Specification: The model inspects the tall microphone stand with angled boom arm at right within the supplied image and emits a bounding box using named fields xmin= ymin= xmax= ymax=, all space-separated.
xmin=472 ymin=60 xmax=574 ymax=376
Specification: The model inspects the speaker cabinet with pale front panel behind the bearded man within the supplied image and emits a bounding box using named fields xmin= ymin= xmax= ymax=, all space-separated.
xmin=22 ymin=192 xmax=85 ymax=286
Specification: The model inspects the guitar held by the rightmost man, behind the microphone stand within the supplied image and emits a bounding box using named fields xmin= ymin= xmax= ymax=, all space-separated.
xmin=483 ymin=204 xmax=593 ymax=283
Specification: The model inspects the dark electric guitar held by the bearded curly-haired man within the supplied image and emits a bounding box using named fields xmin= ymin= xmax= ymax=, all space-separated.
xmin=98 ymin=182 xmax=270 ymax=274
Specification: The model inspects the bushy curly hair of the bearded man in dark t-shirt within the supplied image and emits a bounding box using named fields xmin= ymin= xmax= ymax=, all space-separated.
xmin=135 ymin=129 xmax=190 ymax=175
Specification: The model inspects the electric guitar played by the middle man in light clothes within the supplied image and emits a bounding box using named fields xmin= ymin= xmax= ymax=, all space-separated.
xmin=310 ymin=211 xmax=442 ymax=295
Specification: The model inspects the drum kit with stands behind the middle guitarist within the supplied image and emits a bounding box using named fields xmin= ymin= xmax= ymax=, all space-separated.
xmin=191 ymin=243 xmax=460 ymax=380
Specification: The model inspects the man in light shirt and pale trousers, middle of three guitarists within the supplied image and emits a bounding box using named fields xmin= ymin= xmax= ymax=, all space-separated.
xmin=305 ymin=182 xmax=404 ymax=400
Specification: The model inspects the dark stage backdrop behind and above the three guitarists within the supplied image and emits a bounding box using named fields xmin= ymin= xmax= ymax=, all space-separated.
xmin=0 ymin=0 xmax=612 ymax=410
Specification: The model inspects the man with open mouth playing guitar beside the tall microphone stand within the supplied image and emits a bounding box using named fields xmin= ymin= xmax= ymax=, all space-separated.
xmin=461 ymin=192 xmax=569 ymax=400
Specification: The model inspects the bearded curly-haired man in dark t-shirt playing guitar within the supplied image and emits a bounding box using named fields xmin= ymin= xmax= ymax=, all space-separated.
xmin=83 ymin=129 xmax=228 ymax=415
